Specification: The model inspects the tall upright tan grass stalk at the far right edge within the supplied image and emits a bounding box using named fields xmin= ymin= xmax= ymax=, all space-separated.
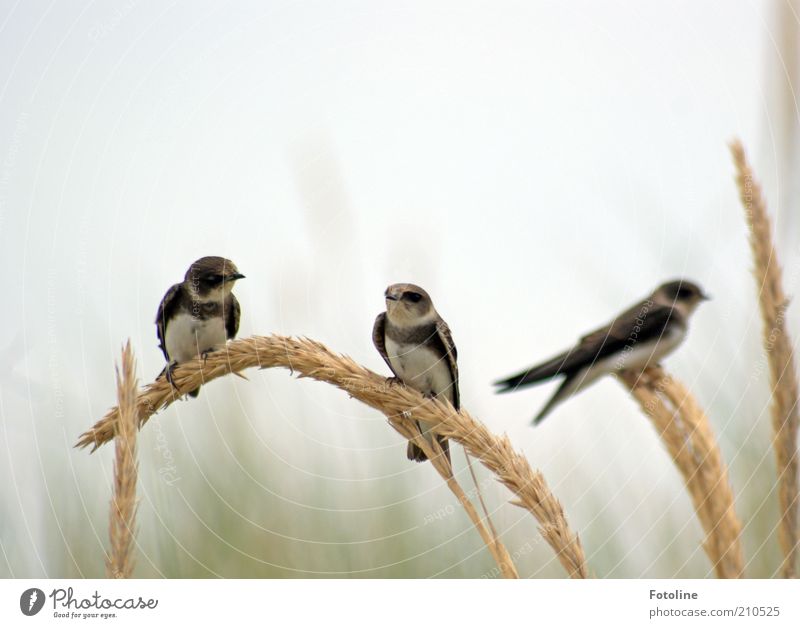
xmin=731 ymin=140 xmax=800 ymax=578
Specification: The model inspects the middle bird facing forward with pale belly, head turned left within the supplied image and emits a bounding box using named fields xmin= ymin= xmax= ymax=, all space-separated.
xmin=372 ymin=283 xmax=460 ymax=462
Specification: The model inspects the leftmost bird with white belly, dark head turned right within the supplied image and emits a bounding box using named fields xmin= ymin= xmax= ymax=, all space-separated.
xmin=156 ymin=256 xmax=244 ymax=397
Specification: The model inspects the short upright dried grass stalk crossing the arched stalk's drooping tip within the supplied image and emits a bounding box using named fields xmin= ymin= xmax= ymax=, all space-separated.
xmin=106 ymin=340 xmax=139 ymax=578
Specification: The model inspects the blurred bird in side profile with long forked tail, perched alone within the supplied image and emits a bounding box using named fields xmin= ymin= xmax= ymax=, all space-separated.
xmin=495 ymin=279 xmax=709 ymax=425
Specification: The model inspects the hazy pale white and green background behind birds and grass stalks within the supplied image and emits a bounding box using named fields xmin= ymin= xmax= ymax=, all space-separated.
xmin=0 ymin=0 xmax=800 ymax=577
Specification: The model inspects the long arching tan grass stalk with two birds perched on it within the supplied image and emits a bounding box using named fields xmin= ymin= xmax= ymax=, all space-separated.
xmin=77 ymin=335 xmax=588 ymax=578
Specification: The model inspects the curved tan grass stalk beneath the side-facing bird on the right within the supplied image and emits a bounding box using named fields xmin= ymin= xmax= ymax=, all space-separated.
xmin=620 ymin=367 xmax=744 ymax=578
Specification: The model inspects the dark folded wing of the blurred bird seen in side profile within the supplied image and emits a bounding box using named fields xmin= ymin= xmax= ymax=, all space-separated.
xmin=495 ymin=302 xmax=679 ymax=392
